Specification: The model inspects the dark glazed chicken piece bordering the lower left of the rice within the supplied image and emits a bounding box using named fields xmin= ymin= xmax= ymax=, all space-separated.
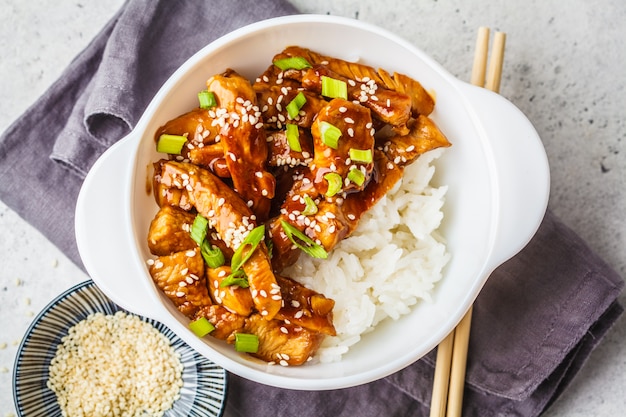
xmin=276 ymin=276 xmax=337 ymax=336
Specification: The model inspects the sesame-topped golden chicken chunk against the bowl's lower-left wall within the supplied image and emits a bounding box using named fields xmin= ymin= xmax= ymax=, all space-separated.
xmin=149 ymin=249 xmax=212 ymax=318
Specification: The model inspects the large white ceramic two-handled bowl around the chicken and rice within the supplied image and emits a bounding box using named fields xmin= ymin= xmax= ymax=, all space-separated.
xmin=76 ymin=15 xmax=549 ymax=390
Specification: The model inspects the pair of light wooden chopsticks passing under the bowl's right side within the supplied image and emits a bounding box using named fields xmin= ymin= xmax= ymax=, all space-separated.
xmin=430 ymin=27 xmax=506 ymax=417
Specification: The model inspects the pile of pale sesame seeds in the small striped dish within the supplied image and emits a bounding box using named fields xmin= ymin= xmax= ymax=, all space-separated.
xmin=47 ymin=311 xmax=183 ymax=417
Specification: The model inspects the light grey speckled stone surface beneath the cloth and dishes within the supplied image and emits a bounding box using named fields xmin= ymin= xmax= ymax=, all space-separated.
xmin=0 ymin=0 xmax=626 ymax=417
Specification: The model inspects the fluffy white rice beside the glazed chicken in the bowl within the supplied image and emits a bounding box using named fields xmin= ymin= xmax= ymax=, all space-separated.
xmin=286 ymin=149 xmax=450 ymax=362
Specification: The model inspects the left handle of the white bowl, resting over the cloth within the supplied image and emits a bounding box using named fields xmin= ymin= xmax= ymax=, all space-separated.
xmin=75 ymin=132 xmax=165 ymax=320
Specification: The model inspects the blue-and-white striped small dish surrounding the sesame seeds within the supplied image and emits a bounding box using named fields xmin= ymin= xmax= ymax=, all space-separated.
xmin=13 ymin=281 xmax=227 ymax=417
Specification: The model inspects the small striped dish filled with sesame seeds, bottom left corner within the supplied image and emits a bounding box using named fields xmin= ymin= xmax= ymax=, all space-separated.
xmin=13 ymin=281 xmax=227 ymax=417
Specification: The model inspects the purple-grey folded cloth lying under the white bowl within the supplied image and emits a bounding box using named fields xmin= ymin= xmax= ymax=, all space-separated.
xmin=0 ymin=0 xmax=624 ymax=417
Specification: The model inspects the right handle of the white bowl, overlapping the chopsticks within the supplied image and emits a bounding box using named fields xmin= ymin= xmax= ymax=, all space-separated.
xmin=461 ymin=83 xmax=550 ymax=268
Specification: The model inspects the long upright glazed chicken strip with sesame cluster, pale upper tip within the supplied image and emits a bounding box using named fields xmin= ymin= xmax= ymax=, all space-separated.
xmin=207 ymin=70 xmax=276 ymax=221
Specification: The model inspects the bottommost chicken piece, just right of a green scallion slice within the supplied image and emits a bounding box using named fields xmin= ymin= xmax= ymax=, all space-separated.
xmin=243 ymin=314 xmax=324 ymax=365
